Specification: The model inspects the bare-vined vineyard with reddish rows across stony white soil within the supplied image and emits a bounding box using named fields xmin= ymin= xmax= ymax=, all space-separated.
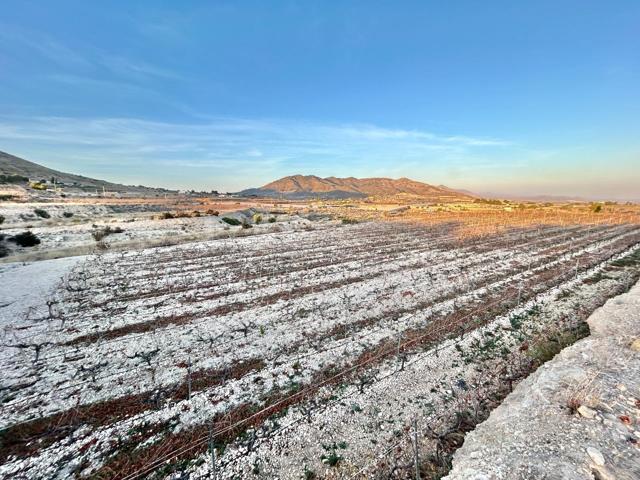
xmin=0 ymin=219 xmax=640 ymax=479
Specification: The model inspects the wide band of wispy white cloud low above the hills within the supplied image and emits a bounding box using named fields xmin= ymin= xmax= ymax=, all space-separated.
xmin=0 ymin=116 xmax=507 ymax=190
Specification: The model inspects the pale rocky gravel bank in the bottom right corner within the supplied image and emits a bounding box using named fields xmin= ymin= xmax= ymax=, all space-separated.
xmin=446 ymin=283 xmax=640 ymax=480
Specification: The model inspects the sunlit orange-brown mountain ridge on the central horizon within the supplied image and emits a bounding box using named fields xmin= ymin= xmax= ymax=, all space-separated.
xmin=239 ymin=175 xmax=472 ymax=201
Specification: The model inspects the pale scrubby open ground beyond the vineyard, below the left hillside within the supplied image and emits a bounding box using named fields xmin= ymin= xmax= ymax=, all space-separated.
xmin=0 ymin=197 xmax=320 ymax=262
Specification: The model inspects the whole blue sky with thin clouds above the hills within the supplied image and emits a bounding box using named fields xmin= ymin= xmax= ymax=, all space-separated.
xmin=0 ymin=0 xmax=640 ymax=198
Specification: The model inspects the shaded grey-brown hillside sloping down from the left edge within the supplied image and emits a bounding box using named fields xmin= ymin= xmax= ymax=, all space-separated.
xmin=0 ymin=151 xmax=174 ymax=196
